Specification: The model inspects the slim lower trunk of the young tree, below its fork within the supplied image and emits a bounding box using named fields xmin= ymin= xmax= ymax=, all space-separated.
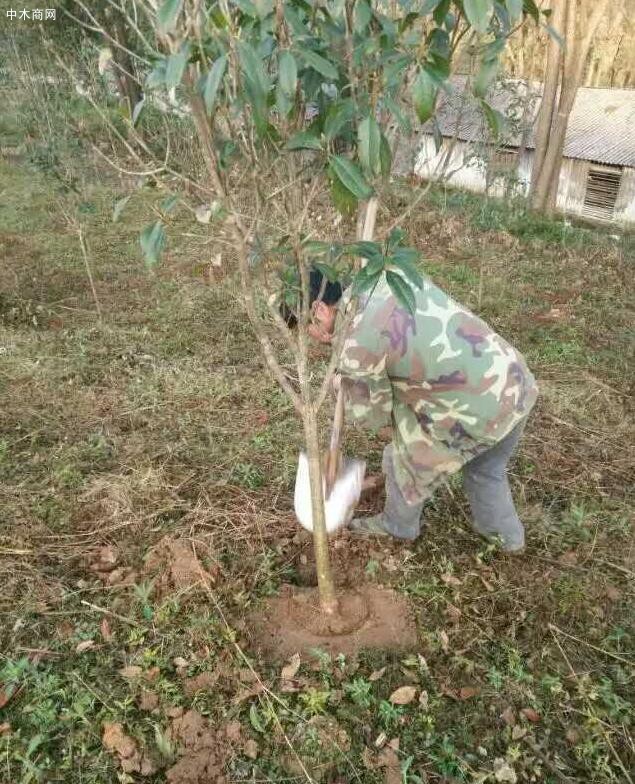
xmin=303 ymin=402 xmax=339 ymax=615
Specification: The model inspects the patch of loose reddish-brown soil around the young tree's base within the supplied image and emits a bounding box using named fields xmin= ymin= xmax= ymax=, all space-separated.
xmin=252 ymin=586 xmax=417 ymax=658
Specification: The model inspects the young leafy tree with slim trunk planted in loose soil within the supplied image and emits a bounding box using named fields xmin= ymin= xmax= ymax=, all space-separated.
xmin=68 ymin=0 xmax=538 ymax=615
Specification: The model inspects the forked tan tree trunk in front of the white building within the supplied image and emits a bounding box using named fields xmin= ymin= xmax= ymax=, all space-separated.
xmin=533 ymin=0 xmax=608 ymax=213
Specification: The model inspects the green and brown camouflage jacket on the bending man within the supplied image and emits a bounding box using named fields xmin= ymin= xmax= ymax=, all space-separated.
xmin=339 ymin=278 xmax=538 ymax=504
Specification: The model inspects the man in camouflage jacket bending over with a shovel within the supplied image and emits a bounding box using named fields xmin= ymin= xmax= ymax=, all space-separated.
xmin=309 ymin=271 xmax=538 ymax=552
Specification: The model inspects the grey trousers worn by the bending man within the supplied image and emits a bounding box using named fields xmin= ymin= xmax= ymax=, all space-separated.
xmin=382 ymin=421 xmax=525 ymax=550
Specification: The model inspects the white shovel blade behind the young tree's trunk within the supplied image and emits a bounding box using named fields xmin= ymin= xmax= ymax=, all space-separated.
xmin=294 ymin=452 xmax=366 ymax=533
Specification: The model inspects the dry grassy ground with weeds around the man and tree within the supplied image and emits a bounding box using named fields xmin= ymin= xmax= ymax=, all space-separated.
xmin=0 ymin=108 xmax=635 ymax=784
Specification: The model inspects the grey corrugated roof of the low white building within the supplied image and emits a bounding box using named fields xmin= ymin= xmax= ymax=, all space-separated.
xmin=423 ymin=77 xmax=635 ymax=167
